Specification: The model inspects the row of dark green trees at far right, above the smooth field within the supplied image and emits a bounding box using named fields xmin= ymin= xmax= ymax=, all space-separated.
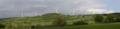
xmin=95 ymin=14 xmax=120 ymax=23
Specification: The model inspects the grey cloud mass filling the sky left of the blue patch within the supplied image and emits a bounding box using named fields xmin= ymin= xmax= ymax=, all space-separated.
xmin=0 ymin=0 xmax=108 ymax=18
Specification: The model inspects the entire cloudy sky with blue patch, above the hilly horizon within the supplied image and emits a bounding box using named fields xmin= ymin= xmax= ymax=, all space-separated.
xmin=0 ymin=0 xmax=120 ymax=18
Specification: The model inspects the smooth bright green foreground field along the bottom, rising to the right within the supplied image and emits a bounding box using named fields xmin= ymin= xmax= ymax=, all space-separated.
xmin=0 ymin=23 xmax=120 ymax=29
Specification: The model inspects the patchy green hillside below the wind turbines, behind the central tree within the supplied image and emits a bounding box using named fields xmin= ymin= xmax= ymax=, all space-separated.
xmin=1 ymin=13 xmax=94 ymax=26
